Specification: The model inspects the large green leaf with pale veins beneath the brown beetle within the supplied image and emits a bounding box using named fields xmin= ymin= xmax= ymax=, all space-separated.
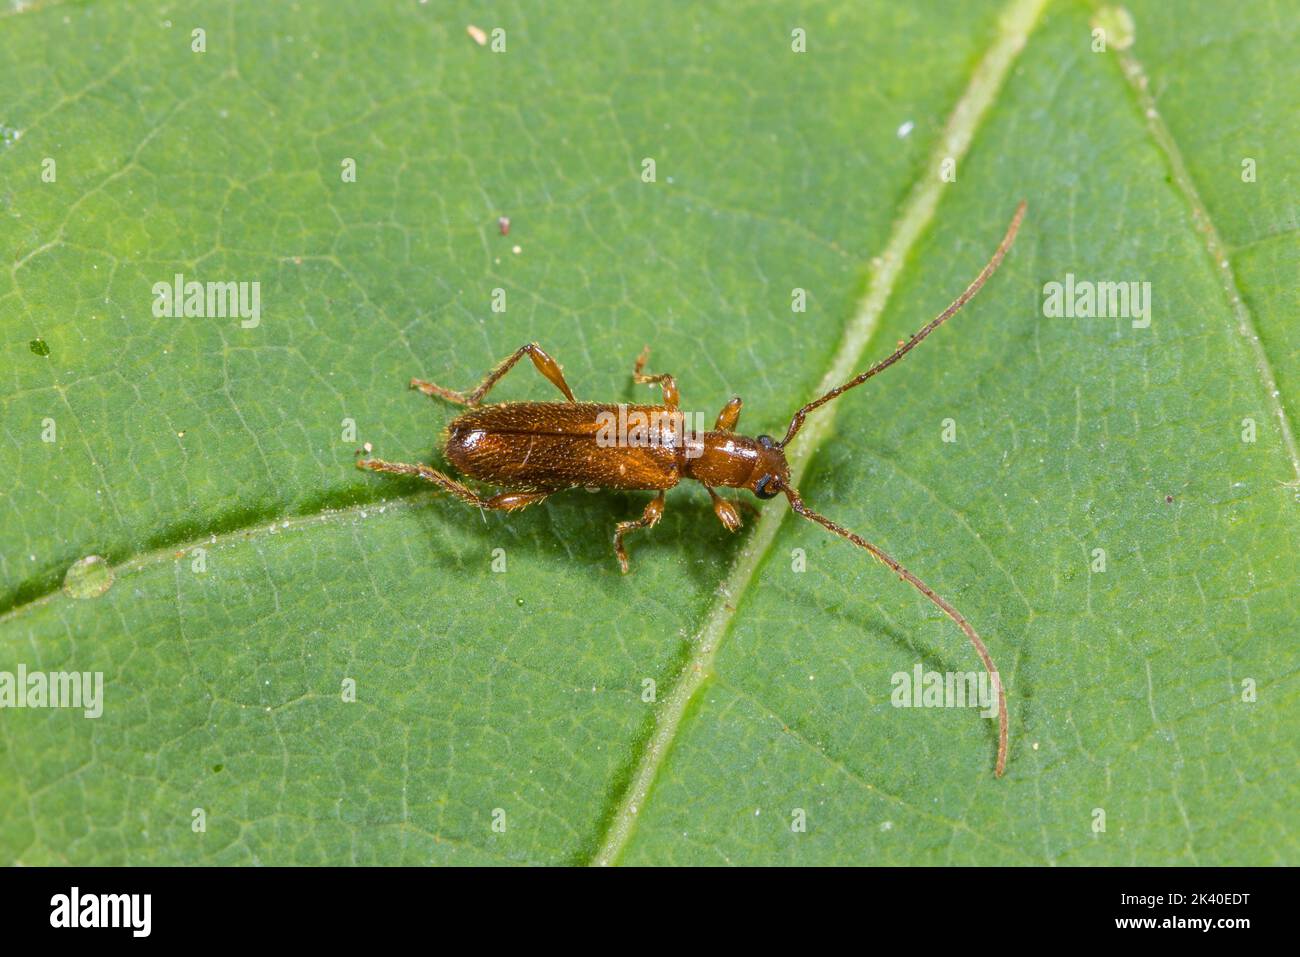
xmin=0 ymin=0 xmax=1300 ymax=865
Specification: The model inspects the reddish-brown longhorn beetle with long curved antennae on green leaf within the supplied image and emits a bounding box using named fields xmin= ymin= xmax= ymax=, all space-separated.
xmin=356 ymin=202 xmax=1024 ymax=778
